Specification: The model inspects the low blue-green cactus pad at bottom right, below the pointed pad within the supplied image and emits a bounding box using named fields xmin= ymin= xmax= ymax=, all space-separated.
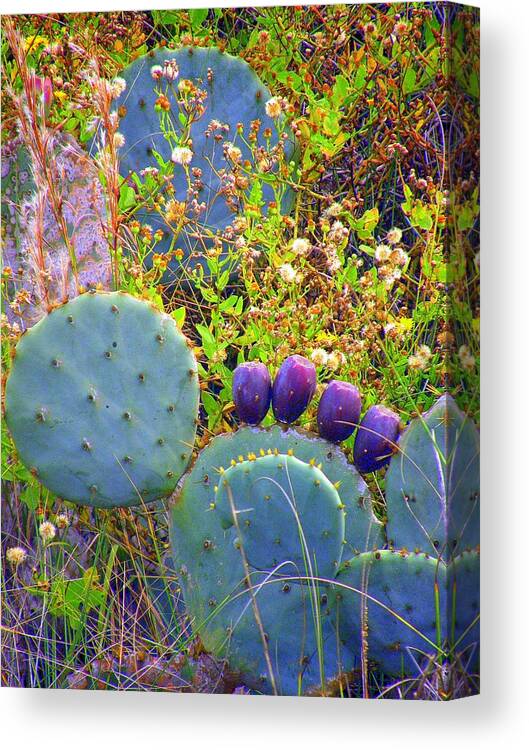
xmin=336 ymin=550 xmax=448 ymax=675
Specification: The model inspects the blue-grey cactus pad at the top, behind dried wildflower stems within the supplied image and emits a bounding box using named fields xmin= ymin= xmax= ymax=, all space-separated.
xmin=112 ymin=47 xmax=294 ymax=283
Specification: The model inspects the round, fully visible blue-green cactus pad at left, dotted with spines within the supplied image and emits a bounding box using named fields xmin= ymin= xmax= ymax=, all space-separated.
xmin=5 ymin=292 xmax=199 ymax=507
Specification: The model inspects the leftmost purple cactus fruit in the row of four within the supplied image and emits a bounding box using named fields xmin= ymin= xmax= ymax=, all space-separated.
xmin=232 ymin=362 xmax=272 ymax=424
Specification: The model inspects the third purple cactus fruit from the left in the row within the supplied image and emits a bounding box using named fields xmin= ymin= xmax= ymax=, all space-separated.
xmin=318 ymin=380 xmax=362 ymax=443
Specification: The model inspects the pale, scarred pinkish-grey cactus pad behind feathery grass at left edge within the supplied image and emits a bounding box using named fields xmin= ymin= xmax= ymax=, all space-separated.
xmin=2 ymin=134 xmax=112 ymax=329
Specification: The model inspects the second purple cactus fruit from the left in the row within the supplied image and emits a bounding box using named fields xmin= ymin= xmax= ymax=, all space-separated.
xmin=272 ymin=354 xmax=316 ymax=424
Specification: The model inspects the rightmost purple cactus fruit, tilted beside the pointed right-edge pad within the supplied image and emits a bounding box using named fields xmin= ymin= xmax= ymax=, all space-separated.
xmin=353 ymin=405 xmax=400 ymax=474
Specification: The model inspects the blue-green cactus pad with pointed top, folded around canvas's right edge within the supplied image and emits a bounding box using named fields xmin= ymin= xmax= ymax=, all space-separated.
xmin=386 ymin=395 xmax=479 ymax=561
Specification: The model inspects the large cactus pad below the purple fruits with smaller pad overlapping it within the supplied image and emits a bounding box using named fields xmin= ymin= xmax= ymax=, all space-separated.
xmin=170 ymin=425 xmax=383 ymax=694
